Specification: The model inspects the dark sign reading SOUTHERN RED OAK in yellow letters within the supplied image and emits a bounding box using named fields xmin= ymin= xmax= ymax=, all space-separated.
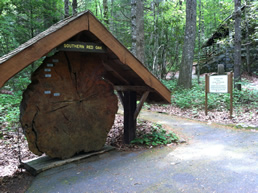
xmin=57 ymin=41 xmax=106 ymax=53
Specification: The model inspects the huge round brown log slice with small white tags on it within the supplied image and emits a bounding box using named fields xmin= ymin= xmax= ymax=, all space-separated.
xmin=20 ymin=52 xmax=118 ymax=159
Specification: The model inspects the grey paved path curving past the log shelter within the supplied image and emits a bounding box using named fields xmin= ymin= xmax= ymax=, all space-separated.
xmin=27 ymin=112 xmax=258 ymax=193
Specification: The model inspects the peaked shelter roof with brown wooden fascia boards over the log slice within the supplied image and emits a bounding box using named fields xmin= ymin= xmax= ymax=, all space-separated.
xmin=0 ymin=11 xmax=171 ymax=103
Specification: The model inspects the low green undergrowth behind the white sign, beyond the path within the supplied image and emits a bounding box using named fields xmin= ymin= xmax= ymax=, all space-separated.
xmin=163 ymin=79 xmax=258 ymax=110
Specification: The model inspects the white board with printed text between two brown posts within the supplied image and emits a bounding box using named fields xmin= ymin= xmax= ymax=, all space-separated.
xmin=209 ymin=75 xmax=228 ymax=93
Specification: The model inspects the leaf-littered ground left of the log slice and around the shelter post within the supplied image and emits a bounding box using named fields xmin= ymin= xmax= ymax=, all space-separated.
xmin=0 ymin=114 xmax=155 ymax=193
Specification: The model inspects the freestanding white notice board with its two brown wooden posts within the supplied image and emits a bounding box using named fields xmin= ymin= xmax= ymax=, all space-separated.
xmin=205 ymin=72 xmax=233 ymax=118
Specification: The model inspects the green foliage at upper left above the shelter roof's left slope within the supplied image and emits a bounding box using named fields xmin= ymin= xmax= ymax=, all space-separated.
xmin=0 ymin=0 xmax=63 ymax=56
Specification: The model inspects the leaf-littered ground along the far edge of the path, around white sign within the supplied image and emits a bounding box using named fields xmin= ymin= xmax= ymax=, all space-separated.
xmin=152 ymin=74 xmax=258 ymax=129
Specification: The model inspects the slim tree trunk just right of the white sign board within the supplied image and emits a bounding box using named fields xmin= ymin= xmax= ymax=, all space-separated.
xmin=234 ymin=0 xmax=241 ymax=90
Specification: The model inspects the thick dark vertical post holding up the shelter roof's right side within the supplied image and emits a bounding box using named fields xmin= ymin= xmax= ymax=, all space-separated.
xmin=123 ymin=91 xmax=136 ymax=144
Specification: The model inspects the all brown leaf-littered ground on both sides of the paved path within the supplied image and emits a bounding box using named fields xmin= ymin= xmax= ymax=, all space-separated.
xmin=0 ymin=73 xmax=258 ymax=193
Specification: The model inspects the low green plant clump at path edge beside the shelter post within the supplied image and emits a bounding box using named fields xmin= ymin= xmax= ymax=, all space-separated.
xmin=131 ymin=124 xmax=178 ymax=146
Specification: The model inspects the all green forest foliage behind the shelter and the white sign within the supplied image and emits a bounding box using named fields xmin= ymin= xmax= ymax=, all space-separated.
xmin=0 ymin=0 xmax=254 ymax=134
